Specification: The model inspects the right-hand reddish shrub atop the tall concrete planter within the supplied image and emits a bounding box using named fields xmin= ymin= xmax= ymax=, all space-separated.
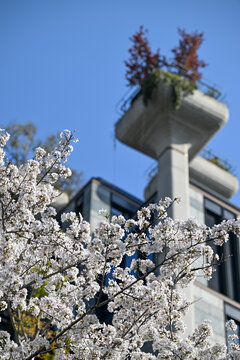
xmin=172 ymin=28 xmax=207 ymax=82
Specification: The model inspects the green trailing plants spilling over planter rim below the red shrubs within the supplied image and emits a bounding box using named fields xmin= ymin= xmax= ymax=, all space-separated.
xmin=141 ymin=69 xmax=197 ymax=110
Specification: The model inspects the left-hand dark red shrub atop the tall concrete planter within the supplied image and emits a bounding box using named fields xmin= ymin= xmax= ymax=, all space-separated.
xmin=125 ymin=26 xmax=162 ymax=86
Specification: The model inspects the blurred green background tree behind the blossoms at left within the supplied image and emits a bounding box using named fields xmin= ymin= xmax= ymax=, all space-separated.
xmin=1 ymin=121 xmax=82 ymax=197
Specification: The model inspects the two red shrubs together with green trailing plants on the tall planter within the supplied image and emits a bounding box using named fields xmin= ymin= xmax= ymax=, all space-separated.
xmin=125 ymin=26 xmax=206 ymax=110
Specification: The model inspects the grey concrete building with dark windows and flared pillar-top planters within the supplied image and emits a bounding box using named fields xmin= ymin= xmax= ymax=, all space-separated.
xmin=62 ymin=82 xmax=240 ymax=342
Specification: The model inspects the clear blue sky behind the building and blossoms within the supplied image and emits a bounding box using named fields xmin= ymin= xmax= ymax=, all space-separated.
xmin=0 ymin=0 xmax=240 ymax=206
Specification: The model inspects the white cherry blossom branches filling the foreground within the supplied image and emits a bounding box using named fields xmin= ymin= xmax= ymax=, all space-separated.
xmin=0 ymin=131 xmax=240 ymax=360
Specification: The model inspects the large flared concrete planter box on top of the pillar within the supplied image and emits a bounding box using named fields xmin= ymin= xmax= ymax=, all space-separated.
xmin=116 ymin=81 xmax=228 ymax=161
